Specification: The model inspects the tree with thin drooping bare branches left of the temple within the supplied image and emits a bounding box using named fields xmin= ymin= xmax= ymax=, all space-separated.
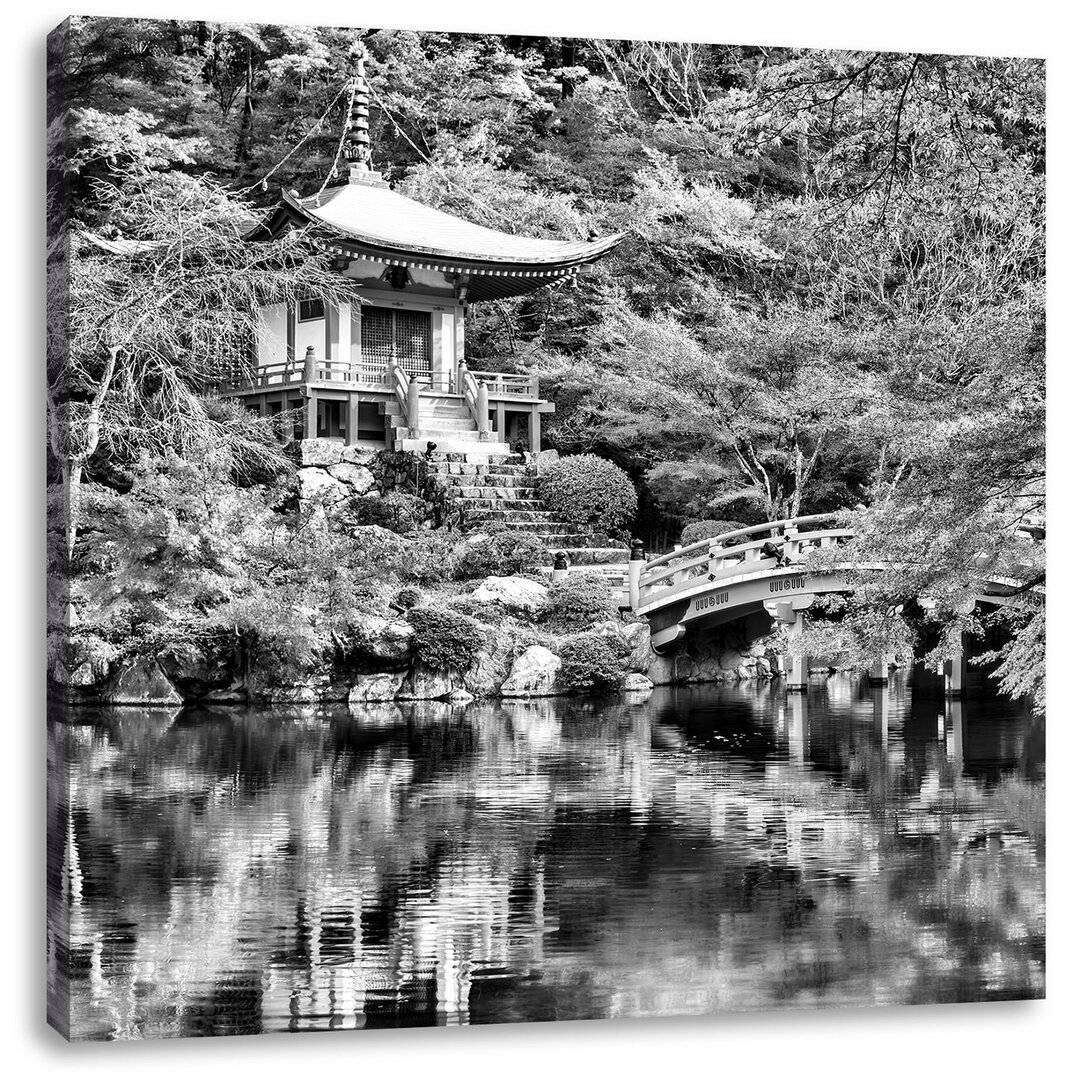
xmin=48 ymin=172 xmax=348 ymax=550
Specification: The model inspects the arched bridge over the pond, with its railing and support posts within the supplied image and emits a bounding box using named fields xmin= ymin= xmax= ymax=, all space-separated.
xmin=630 ymin=514 xmax=1029 ymax=693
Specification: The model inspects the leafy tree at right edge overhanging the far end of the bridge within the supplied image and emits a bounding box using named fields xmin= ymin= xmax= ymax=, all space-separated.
xmin=813 ymin=297 xmax=1047 ymax=710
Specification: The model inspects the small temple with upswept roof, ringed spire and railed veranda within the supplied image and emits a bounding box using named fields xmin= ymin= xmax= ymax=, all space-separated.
xmin=232 ymin=55 xmax=622 ymax=453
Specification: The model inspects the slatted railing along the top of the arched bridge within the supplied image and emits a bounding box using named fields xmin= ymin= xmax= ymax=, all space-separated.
xmin=636 ymin=514 xmax=853 ymax=607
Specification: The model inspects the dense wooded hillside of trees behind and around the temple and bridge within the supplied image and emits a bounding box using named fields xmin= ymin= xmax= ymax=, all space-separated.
xmin=49 ymin=17 xmax=1045 ymax=708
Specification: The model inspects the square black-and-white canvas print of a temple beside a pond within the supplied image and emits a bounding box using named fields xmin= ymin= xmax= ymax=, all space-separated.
xmin=44 ymin=13 xmax=1047 ymax=1040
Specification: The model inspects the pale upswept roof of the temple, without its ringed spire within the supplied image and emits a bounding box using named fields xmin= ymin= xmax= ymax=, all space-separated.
xmin=253 ymin=181 xmax=623 ymax=300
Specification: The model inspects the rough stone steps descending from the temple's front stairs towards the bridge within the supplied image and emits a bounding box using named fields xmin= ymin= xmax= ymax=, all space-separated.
xmin=428 ymin=440 xmax=630 ymax=598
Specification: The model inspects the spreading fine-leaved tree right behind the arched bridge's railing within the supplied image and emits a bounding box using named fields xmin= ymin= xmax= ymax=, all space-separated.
xmin=557 ymin=308 xmax=878 ymax=519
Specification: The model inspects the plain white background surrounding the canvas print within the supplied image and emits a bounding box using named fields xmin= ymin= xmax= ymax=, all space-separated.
xmin=0 ymin=0 xmax=1080 ymax=1080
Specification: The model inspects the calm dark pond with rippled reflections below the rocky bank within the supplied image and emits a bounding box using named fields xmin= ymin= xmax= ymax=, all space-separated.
xmin=49 ymin=673 xmax=1044 ymax=1039
